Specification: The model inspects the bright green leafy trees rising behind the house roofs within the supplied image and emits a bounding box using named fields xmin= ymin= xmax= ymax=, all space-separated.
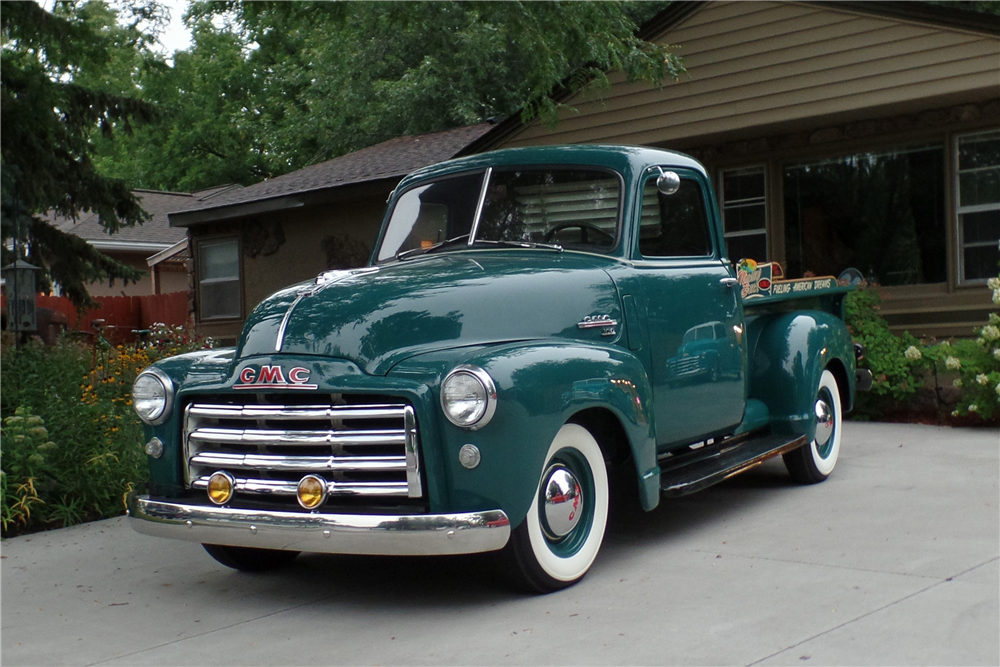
xmin=101 ymin=1 xmax=683 ymax=190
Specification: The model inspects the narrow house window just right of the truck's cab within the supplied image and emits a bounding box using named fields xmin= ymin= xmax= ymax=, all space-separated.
xmin=721 ymin=167 xmax=767 ymax=261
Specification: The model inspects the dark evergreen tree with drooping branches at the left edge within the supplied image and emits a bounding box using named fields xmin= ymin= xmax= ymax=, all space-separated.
xmin=0 ymin=2 xmax=154 ymax=306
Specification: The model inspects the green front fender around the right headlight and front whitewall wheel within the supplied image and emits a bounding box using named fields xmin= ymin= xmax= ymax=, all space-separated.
xmin=390 ymin=342 xmax=659 ymax=526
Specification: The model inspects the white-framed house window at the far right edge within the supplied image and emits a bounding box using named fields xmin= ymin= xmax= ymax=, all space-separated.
xmin=955 ymin=132 xmax=1000 ymax=282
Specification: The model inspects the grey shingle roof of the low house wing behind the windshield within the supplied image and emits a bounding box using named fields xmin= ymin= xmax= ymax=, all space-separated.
xmin=178 ymin=123 xmax=493 ymax=210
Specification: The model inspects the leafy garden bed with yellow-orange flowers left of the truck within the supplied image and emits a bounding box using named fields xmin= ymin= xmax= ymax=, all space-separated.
xmin=0 ymin=325 xmax=212 ymax=536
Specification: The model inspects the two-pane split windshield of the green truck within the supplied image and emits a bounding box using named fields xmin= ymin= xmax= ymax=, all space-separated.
xmin=378 ymin=167 xmax=621 ymax=261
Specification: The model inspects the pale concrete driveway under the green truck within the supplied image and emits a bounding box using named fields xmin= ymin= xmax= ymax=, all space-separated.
xmin=0 ymin=423 xmax=1000 ymax=665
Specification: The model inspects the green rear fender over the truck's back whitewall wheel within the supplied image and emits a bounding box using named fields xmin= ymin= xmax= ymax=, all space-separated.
xmin=749 ymin=310 xmax=854 ymax=440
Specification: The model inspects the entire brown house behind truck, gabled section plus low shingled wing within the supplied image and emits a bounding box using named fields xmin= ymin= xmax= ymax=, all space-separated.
xmin=170 ymin=0 xmax=1000 ymax=340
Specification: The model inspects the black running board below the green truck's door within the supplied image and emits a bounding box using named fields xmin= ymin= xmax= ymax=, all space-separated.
xmin=660 ymin=433 xmax=806 ymax=497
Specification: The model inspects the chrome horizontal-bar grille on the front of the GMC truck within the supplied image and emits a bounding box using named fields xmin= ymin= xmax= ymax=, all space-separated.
xmin=184 ymin=399 xmax=423 ymax=499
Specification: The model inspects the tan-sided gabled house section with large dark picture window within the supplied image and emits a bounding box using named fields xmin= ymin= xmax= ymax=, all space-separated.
xmin=470 ymin=1 xmax=1000 ymax=336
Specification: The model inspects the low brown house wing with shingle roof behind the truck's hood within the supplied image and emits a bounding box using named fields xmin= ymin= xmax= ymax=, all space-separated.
xmin=169 ymin=123 xmax=492 ymax=341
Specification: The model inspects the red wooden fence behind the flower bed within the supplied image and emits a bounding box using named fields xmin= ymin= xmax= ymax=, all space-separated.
xmin=0 ymin=292 xmax=188 ymax=344
